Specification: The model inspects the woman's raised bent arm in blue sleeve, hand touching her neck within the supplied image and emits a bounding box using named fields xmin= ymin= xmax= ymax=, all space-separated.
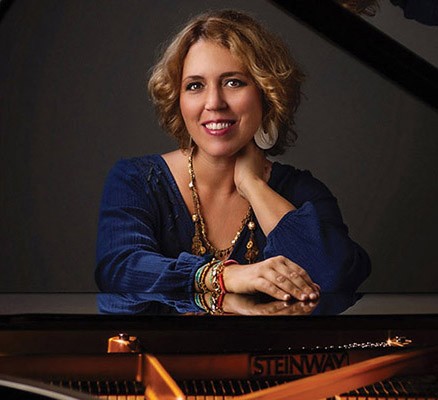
xmin=231 ymin=144 xmax=370 ymax=292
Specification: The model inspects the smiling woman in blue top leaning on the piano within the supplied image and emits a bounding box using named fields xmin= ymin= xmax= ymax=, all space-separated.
xmin=96 ymin=10 xmax=370 ymax=310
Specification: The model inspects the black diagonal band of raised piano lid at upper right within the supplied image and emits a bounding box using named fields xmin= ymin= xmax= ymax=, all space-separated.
xmin=271 ymin=0 xmax=438 ymax=108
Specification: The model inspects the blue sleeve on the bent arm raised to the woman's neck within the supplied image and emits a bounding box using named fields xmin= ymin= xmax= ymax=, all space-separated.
xmin=264 ymin=171 xmax=370 ymax=292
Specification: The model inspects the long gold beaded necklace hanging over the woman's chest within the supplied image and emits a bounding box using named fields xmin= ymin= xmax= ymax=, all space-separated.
xmin=188 ymin=148 xmax=259 ymax=264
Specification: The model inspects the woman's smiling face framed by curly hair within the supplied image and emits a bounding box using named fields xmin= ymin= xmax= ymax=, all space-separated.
xmin=180 ymin=40 xmax=262 ymax=157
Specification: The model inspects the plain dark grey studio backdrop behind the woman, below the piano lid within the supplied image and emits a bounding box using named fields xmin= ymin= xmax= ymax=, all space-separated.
xmin=0 ymin=0 xmax=438 ymax=292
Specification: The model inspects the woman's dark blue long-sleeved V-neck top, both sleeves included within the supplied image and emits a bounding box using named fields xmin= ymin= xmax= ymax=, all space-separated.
xmin=96 ymin=155 xmax=370 ymax=293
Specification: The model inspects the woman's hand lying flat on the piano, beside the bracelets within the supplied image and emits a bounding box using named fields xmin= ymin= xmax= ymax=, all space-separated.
xmin=223 ymin=256 xmax=320 ymax=301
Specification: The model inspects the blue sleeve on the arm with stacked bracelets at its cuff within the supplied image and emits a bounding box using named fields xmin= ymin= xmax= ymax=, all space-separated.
xmin=95 ymin=160 xmax=206 ymax=293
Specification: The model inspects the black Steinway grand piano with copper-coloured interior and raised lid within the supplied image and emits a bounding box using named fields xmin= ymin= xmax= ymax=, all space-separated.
xmin=0 ymin=0 xmax=438 ymax=400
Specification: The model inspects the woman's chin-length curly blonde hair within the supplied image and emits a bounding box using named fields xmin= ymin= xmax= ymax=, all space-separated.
xmin=148 ymin=10 xmax=304 ymax=155
